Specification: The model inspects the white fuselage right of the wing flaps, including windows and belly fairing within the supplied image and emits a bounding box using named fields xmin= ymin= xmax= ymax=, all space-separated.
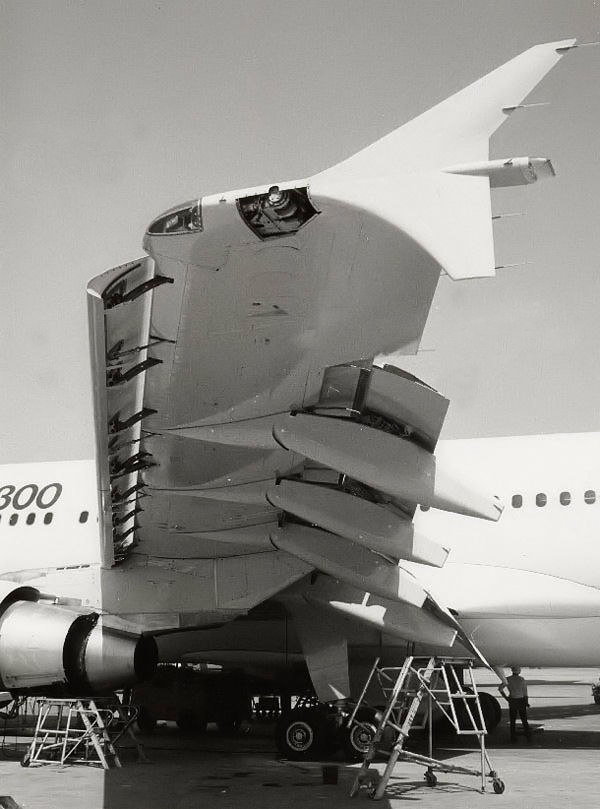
xmin=415 ymin=433 xmax=600 ymax=666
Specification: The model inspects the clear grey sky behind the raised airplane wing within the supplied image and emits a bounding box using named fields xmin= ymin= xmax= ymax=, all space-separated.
xmin=0 ymin=0 xmax=600 ymax=463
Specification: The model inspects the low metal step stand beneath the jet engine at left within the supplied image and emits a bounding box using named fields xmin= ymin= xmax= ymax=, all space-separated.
xmin=21 ymin=695 xmax=145 ymax=770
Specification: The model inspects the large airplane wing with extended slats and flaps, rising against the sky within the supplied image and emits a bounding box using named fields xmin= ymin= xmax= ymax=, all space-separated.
xmin=88 ymin=40 xmax=573 ymax=696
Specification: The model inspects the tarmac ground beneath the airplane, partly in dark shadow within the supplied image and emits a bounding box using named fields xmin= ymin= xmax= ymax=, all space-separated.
xmin=0 ymin=669 xmax=600 ymax=809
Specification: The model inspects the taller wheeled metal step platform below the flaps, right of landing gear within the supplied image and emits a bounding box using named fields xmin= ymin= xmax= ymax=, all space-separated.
xmin=348 ymin=657 xmax=504 ymax=800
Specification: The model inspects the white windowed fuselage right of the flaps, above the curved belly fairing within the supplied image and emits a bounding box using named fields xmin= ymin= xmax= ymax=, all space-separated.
xmin=415 ymin=433 xmax=600 ymax=587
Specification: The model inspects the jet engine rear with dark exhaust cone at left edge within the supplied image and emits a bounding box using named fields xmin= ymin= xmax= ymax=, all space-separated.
xmin=0 ymin=587 xmax=158 ymax=695
